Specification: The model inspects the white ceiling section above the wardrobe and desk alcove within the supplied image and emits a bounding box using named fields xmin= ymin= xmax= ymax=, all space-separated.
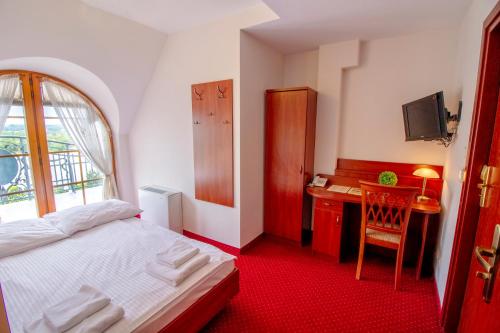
xmin=247 ymin=0 xmax=472 ymax=53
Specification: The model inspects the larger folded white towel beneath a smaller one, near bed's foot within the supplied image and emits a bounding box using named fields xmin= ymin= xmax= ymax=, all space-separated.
xmin=146 ymin=254 xmax=210 ymax=287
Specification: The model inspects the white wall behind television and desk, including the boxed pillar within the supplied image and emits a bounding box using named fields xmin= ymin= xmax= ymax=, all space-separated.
xmin=284 ymin=29 xmax=458 ymax=173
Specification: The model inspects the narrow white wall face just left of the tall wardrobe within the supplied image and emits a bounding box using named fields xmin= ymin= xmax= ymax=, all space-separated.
xmin=240 ymin=32 xmax=283 ymax=247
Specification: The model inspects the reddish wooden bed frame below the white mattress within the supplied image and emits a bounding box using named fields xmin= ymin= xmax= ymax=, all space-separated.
xmin=0 ymin=268 xmax=240 ymax=333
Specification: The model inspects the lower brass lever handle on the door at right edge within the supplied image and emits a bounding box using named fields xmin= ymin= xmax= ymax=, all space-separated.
xmin=474 ymin=224 xmax=500 ymax=303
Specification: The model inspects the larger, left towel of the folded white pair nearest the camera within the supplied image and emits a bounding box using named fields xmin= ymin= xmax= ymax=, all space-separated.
xmin=43 ymin=285 xmax=111 ymax=332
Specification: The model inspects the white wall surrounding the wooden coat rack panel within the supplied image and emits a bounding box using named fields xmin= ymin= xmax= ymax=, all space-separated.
xmin=130 ymin=5 xmax=275 ymax=247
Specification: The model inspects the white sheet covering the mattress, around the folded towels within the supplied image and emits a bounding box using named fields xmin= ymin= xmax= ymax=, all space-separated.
xmin=0 ymin=218 xmax=234 ymax=333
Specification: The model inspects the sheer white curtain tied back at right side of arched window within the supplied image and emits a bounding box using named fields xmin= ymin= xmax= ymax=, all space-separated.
xmin=42 ymin=80 xmax=118 ymax=199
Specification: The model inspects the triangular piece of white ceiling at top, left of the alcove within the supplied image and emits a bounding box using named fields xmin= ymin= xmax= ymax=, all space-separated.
xmin=81 ymin=0 xmax=262 ymax=34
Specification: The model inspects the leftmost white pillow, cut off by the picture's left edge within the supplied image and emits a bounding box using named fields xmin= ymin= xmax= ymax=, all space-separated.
xmin=0 ymin=219 xmax=68 ymax=258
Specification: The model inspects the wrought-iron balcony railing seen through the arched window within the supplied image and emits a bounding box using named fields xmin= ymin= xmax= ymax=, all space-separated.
xmin=0 ymin=136 xmax=103 ymax=205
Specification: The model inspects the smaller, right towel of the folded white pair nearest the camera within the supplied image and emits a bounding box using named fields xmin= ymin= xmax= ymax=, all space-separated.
xmin=68 ymin=303 xmax=125 ymax=333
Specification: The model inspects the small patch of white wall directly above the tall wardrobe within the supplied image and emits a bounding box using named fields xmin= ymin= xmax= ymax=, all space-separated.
xmin=283 ymin=50 xmax=319 ymax=90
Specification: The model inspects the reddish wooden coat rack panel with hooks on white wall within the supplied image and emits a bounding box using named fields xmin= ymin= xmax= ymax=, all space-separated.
xmin=191 ymin=80 xmax=234 ymax=207
